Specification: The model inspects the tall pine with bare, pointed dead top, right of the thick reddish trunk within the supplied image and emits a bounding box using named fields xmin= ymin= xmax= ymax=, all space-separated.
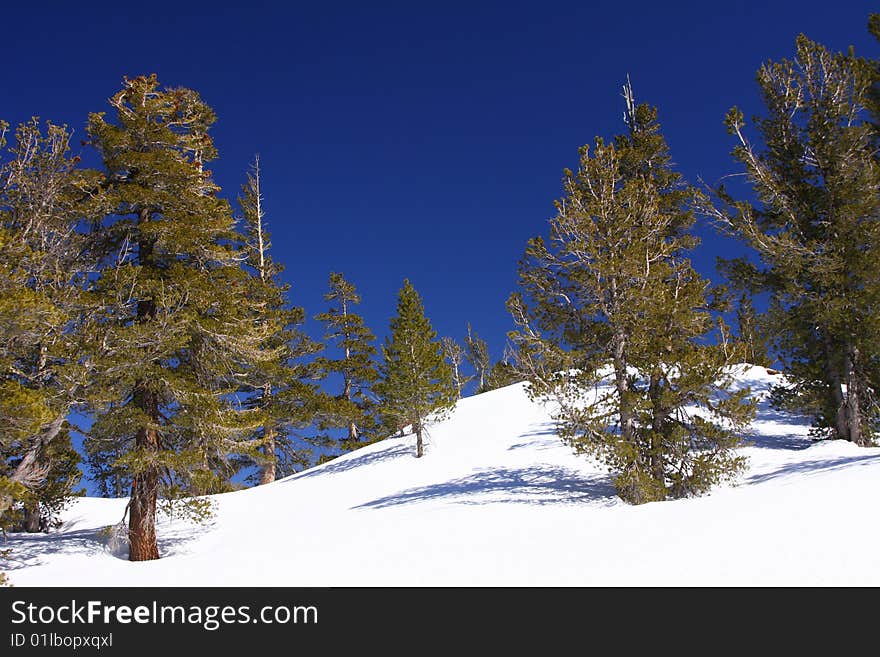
xmin=238 ymin=156 xmax=322 ymax=484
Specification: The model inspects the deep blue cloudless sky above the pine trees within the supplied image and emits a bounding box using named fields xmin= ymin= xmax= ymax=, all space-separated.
xmin=0 ymin=0 xmax=880 ymax=368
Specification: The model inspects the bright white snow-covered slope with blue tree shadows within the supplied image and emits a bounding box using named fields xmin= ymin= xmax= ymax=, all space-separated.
xmin=0 ymin=367 xmax=880 ymax=586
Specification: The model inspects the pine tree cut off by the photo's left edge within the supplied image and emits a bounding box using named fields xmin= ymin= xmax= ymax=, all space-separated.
xmin=0 ymin=118 xmax=99 ymax=514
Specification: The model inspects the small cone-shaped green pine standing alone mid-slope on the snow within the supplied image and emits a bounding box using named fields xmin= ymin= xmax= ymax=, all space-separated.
xmin=376 ymin=280 xmax=456 ymax=457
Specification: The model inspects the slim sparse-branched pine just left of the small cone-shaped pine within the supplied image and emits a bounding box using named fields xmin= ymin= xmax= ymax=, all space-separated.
xmin=315 ymin=272 xmax=379 ymax=449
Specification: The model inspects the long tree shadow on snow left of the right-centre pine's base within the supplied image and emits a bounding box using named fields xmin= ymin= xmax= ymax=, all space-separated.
xmin=353 ymin=467 xmax=617 ymax=509
